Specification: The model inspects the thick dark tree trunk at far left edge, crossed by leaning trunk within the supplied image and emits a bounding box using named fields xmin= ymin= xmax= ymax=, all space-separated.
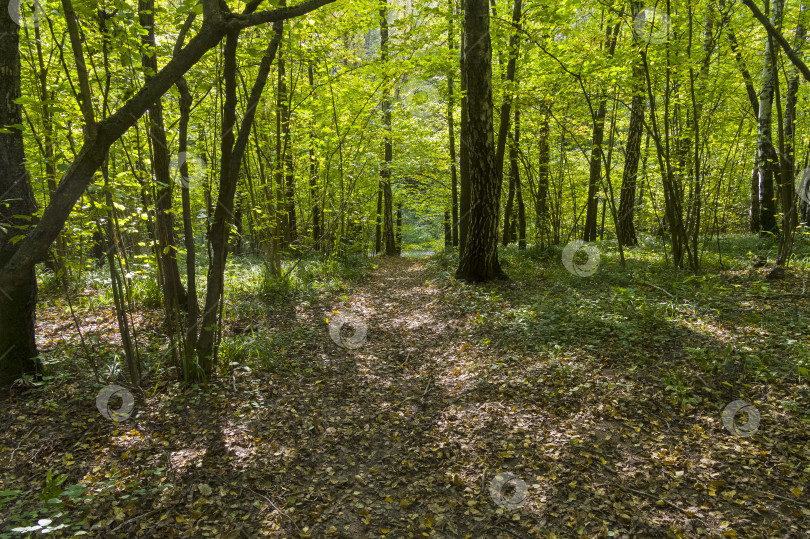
xmin=0 ymin=0 xmax=39 ymax=387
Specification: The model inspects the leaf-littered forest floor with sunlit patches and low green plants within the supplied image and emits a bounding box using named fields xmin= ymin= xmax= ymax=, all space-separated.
xmin=0 ymin=244 xmax=810 ymax=539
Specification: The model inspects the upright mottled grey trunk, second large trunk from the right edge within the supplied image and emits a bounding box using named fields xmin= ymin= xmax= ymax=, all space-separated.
xmin=757 ymin=0 xmax=784 ymax=235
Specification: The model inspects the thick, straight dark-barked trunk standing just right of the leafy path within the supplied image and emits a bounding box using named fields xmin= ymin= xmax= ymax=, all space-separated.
xmin=456 ymin=0 xmax=506 ymax=282
